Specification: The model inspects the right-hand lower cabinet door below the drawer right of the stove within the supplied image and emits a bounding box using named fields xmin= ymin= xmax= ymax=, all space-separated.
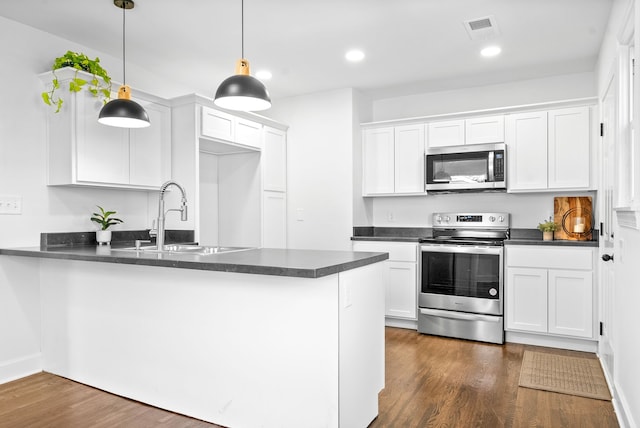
xmin=549 ymin=269 xmax=593 ymax=338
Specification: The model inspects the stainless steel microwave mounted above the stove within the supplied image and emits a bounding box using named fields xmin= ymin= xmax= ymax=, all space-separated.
xmin=426 ymin=143 xmax=507 ymax=193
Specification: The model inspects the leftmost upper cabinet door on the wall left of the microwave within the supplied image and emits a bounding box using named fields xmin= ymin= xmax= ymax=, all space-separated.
xmin=362 ymin=128 xmax=394 ymax=196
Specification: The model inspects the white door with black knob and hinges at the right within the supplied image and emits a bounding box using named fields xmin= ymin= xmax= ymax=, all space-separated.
xmin=598 ymin=73 xmax=618 ymax=379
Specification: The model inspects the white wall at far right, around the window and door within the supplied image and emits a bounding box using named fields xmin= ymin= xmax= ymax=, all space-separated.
xmin=597 ymin=0 xmax=640 ymax=428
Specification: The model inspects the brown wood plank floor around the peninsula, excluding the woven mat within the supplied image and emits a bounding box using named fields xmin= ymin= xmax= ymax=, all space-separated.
xmin=0 ymin=328 xmax=618 ymax=428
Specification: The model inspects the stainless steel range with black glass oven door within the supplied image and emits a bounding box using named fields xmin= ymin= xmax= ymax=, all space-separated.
xmin=418 ymin=212 xmax=509 ymax=343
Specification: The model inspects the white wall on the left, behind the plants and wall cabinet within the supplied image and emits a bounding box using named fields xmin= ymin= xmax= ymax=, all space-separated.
xmin=0 ymin=17 xmax=192 ymax=383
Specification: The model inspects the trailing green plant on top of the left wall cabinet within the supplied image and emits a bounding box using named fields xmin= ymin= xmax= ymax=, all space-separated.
xmin=42 ymin=51 xmax=111 ymax=113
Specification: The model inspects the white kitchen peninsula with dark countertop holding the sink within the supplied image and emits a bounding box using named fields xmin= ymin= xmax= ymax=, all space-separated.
xmin=0 ymin=242 xmax=387 ymax=427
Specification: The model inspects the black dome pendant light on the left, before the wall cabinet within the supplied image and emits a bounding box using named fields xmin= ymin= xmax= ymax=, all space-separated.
xmin=98 ymin=0 xmax=151 ymax=128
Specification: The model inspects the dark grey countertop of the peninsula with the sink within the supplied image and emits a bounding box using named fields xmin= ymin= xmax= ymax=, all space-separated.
xmin=0 ymin=245 xmax=389 ymax=278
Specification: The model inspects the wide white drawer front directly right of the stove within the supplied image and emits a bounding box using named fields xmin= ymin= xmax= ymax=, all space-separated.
xmin=506 ymin=246 xmax=593 ymax=270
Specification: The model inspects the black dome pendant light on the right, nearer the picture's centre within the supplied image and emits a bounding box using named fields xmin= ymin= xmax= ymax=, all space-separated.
xmin=213 ymin=0 xmax=271 ymax=111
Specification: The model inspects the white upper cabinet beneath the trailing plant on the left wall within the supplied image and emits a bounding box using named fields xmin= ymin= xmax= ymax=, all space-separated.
xmin=41 ymin=69 xmax=171 ymax=189
